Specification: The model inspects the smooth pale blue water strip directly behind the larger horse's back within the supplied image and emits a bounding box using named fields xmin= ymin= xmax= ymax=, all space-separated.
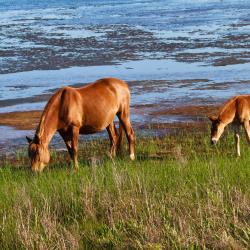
xmin=0 ymin=59 xmax=250 ymax=113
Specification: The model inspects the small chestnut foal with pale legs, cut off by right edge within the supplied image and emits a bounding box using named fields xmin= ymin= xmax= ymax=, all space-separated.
xmin=209 ymin=95 xmax=250 ymax=156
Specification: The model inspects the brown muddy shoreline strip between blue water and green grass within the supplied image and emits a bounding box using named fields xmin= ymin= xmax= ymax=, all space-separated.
xmin=0 ymin=98 xmax=218 ymax=156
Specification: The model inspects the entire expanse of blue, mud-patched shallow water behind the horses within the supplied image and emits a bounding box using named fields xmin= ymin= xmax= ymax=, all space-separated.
xmin=0 ymin=0 xmax=250 ymax=152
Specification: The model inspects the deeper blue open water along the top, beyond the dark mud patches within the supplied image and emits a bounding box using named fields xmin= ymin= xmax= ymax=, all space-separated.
xmin=0 ymin=0 xmax=250 ymax=30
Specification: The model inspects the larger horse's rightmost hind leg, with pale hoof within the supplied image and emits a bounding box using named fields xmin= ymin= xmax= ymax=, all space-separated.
xmin=118 ymin=110 xmax=135 ymax=160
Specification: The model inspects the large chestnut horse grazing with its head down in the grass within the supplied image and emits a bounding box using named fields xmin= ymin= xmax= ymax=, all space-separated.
xmin=27 ymin=78 xmax=135 ymax=171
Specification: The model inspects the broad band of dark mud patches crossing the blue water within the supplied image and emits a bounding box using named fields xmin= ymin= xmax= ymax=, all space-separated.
xmin=0 ymin=22 xmax=250 ymax=74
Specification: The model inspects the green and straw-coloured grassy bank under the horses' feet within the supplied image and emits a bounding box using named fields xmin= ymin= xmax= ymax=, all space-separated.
xmin=0 ymin=132 xmax=250 ymax=249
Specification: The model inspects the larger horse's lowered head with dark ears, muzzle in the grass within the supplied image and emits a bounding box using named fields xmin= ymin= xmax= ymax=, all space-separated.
xmin=26 ymin=135 xmax=50 ymax=172
